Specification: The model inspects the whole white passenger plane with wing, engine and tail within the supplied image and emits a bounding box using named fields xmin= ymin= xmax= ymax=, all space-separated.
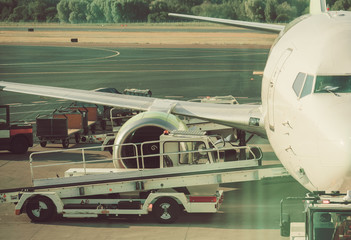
xmin=0 ymin=0 xmax=351 ymax=192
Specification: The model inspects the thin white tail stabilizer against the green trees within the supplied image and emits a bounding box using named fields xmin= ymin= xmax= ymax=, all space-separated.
xmin=168 ymin=13 xmax=285 ymax=33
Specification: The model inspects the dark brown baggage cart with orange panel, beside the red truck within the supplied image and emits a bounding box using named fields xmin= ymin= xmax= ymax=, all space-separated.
xmin=36 ymin=109 xmax=88 ymax=148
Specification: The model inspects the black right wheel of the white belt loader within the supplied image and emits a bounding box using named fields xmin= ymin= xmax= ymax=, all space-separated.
xmin=152 ymin=197 xmax=180 ymax=223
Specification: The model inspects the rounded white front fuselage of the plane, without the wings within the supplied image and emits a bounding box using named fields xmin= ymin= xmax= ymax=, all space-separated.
xmin=262 ymin=12 xmax=351 ymax=192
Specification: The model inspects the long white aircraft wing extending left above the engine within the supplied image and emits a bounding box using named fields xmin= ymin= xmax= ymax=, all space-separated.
xmin=0 ymin=81 xmax=266 ymax=136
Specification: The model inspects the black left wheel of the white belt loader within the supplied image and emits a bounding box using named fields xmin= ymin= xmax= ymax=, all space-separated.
xmin=26 ymin=197 xmax=56 ymax=222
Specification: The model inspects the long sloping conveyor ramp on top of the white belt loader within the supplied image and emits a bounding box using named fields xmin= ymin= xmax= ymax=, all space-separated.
xmin=0 ymin=141 xmax=289 ymax=202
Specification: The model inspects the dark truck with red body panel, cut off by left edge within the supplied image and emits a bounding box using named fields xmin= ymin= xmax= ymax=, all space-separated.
xmin=0 ymin=105 xmax=33 ymax=153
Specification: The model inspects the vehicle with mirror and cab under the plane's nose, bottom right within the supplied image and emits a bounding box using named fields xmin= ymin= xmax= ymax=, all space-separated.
xmin=280 ymin=191 xmax=351 ymax=240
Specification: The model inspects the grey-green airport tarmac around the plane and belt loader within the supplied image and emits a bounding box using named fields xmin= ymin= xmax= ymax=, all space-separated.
xmin=0 ymin=34 xmax=306 ymax=240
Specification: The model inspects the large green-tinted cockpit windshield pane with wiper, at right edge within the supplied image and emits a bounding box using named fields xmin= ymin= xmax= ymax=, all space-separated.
xmin=314 ymin=76 xmax=351 ymax=93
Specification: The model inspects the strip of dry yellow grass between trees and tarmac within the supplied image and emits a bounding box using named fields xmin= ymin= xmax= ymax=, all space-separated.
xmin=0 ymin=23 xmax=276 ymax=48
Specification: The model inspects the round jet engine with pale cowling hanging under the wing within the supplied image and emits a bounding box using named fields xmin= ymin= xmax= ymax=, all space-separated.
xmin=113 ymin=111 xmax=187 ymax=168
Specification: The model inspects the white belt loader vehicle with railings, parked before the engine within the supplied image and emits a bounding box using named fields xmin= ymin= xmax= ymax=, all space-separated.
xmin=0 ymin=133 xmax=288 ymax=223
